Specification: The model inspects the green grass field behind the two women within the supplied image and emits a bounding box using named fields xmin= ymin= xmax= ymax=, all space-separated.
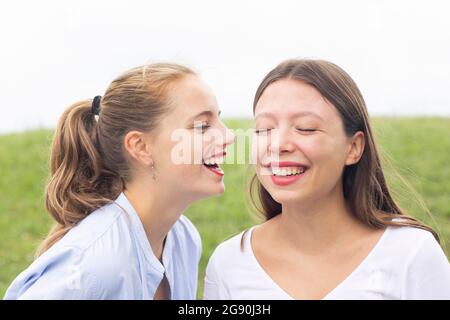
xmin=0 ymin=118 xmax=450 ymax=298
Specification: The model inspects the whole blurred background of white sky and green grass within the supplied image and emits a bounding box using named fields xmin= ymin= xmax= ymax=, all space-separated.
xmin=0 ymin=0 xmax=450 ymax=297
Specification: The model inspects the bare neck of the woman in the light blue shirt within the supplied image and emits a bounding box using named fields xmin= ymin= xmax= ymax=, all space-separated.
xmin=124 ymin=176 xmax=189 ymax=261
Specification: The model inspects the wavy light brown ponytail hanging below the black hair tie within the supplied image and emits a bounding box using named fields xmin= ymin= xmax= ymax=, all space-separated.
xmin=36 ymin=100 xmax=123 ymax=256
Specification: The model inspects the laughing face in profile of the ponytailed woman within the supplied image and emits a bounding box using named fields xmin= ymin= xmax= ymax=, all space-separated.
xmin=149 ymin=75 xmax=234 ymax=200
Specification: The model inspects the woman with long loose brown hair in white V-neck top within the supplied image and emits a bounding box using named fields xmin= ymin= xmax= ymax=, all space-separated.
xmin=205 ymin=60 xmax=450 ymax=299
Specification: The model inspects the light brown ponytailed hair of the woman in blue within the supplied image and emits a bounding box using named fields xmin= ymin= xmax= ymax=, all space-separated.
xmin=36 ymin=63 xmax=194 ymax=256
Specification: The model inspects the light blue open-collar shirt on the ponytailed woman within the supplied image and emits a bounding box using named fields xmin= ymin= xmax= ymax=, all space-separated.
xmin=5 ymin=193 xmax=202 ymax=299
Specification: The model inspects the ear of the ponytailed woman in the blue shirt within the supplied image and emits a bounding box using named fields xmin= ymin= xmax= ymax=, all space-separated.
xmin=123 ymin=131 xmax=153 ymax=166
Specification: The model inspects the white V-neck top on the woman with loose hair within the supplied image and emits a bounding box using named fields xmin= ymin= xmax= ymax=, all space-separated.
xmin=204 ymin=227 xmax=450 ymax=300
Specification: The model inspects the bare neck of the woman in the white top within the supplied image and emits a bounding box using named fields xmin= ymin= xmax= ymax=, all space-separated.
xmin=277 ymin=184 xmax=366 ymax=253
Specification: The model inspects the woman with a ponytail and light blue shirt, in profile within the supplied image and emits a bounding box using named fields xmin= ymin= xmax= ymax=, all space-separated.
xmin=5 ymin=64 xmax=233 ymax=299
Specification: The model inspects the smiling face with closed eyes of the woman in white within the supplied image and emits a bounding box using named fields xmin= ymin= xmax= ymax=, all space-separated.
xmin=253 ymin=79 xmax=364 ymax=204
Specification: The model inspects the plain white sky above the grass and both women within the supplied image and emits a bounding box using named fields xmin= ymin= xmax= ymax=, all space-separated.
xmin=0 ymin=0 xmax=450 ymax=132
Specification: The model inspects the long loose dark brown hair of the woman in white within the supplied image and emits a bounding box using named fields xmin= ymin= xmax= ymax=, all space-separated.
xmin=249 ymin=59 xmax=439 ymax=241
